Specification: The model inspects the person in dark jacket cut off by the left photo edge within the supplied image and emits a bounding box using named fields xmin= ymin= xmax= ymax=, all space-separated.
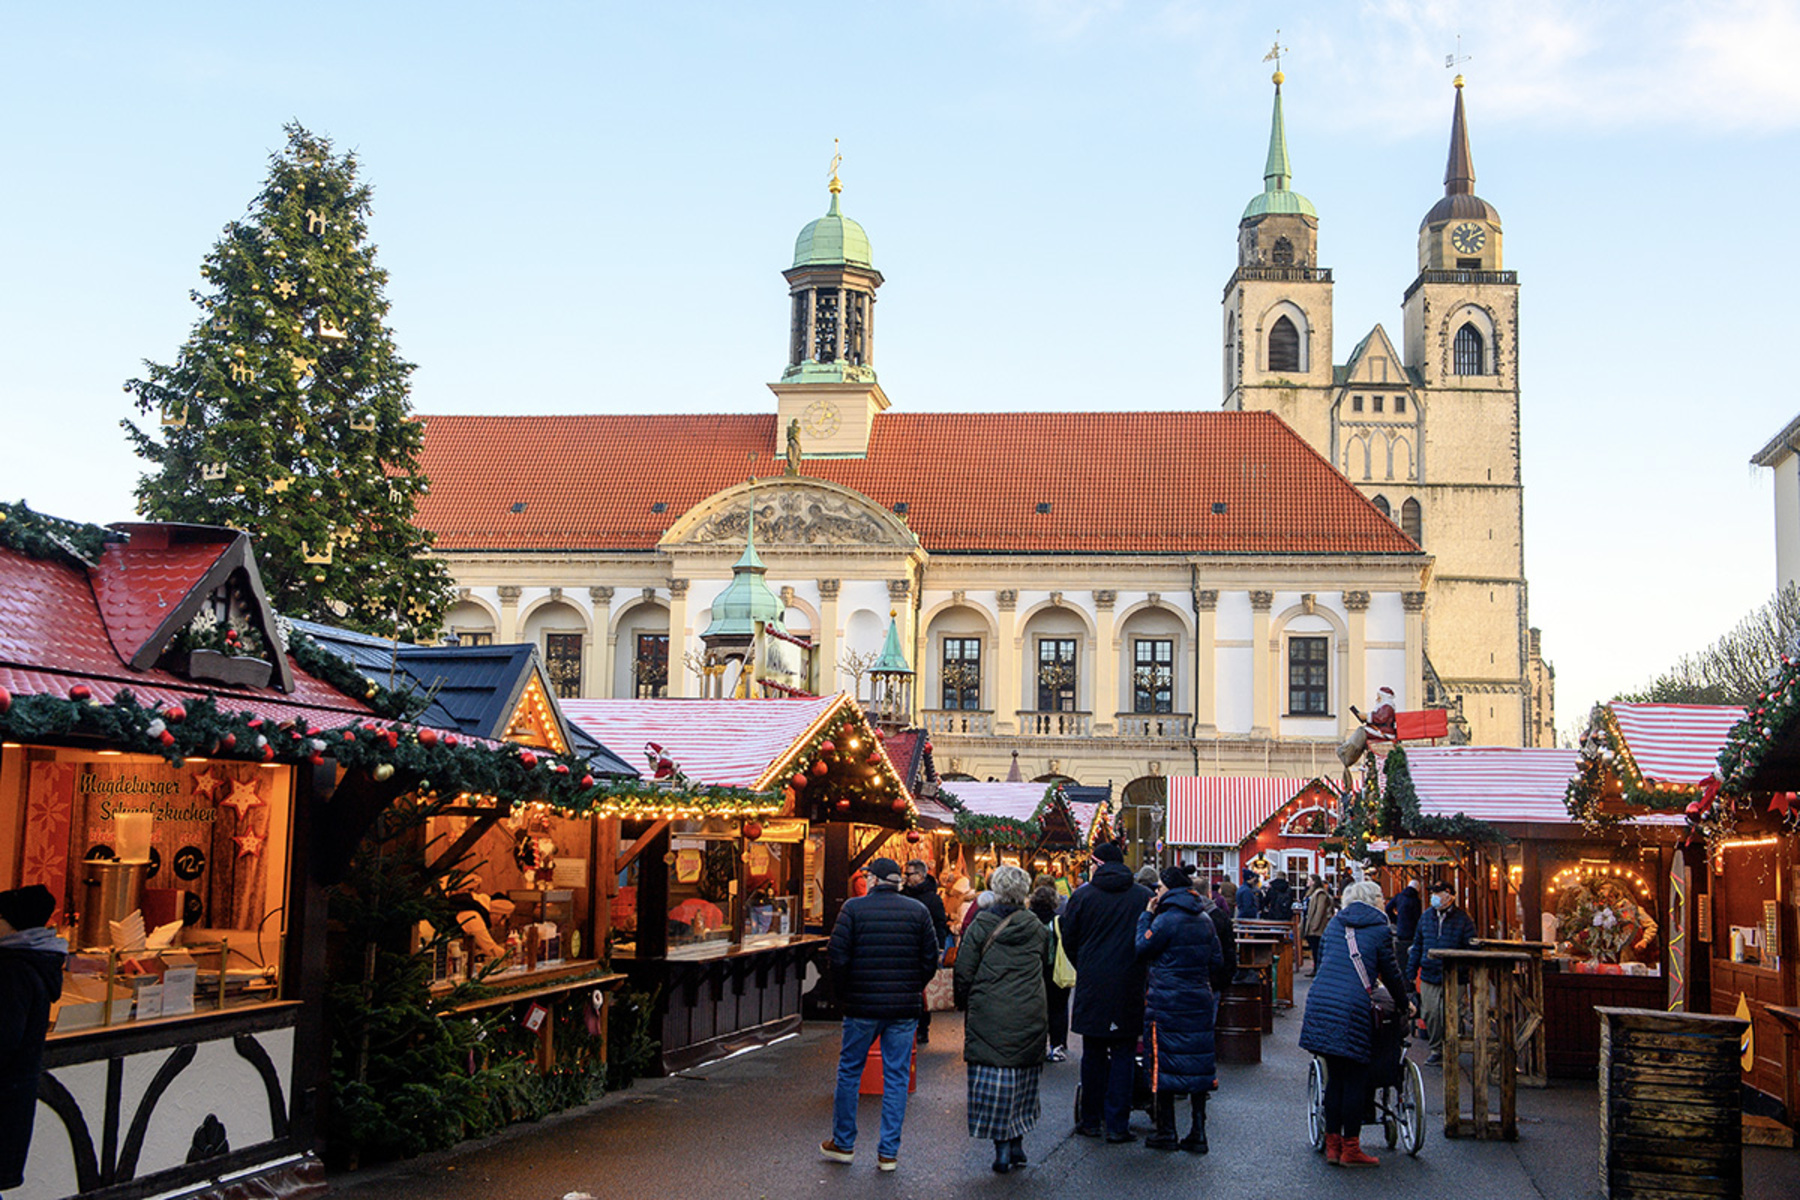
xmin=0 ymin=883 xmax=68 ymax=1191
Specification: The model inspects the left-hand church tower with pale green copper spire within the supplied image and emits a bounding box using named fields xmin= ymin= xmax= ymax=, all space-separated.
xmin=1224 ymin=70 xmax=1332 ymax=448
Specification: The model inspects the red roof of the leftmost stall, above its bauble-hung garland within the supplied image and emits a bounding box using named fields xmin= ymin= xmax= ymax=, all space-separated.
xmin=0 ymin=547 xmax=369 ymax=721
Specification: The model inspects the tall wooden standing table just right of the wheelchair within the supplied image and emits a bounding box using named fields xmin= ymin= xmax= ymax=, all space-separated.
xmin=1431 ymin=950 xmax=1539 ymax=1142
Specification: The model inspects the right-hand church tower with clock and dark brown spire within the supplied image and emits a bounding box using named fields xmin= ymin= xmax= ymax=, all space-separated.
xmin=1402 ymin=76 xmax=1543 ymax=745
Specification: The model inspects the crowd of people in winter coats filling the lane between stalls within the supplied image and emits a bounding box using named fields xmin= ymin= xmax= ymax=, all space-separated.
xmin=819 ymin=842 xmax=1474 ymax=1173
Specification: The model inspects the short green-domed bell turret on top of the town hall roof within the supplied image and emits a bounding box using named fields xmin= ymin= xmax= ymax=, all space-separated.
xmin=769 ymin=158 xmax=887 ymax=459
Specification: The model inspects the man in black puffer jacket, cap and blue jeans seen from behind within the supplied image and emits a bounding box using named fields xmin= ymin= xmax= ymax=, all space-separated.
xmin=819 ymin=858 xmax=940 ymax=1171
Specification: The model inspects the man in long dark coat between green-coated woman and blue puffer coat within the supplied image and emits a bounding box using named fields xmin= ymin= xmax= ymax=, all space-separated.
xmin=1062 ymin=842 xmax=1150 ymax=1142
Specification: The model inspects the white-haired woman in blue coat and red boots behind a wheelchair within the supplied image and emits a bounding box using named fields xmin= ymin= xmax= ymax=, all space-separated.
xmin=1300 ymin=880 xmax=1413 ymax=1166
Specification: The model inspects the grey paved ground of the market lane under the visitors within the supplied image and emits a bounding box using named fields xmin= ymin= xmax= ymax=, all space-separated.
xmin=333 ymin=978 xmax=1800 ymax=1200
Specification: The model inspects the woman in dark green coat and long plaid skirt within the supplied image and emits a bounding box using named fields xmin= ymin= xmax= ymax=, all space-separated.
xmin=954 ymin=867 xmax=1051 ymax=1175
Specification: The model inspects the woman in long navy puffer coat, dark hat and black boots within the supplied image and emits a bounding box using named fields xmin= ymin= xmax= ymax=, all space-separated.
xmin=1138 ymin=867 xmax=1224 ymax=1155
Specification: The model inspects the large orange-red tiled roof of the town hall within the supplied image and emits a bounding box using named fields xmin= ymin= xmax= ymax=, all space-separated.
xmin=419 ymin=412 xmax=1420 ymax=554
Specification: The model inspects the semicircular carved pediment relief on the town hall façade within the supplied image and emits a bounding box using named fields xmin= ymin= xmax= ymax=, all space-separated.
xmin=662 ymin=479 xmax=918 ymax=549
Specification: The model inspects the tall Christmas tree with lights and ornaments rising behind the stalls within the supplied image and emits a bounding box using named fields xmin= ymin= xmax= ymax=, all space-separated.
xmin=122 ymin=124 xmax=452 ymax=633
